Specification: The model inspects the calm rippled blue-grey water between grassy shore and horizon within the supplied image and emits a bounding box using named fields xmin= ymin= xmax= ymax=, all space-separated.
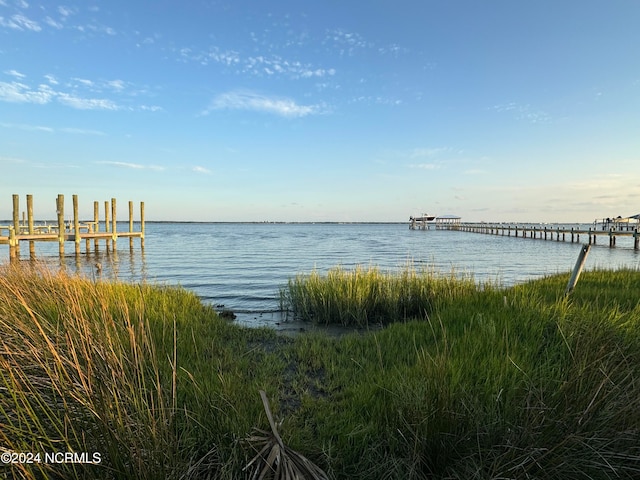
xmin=6 ymin=223 xmax=640 ymax=325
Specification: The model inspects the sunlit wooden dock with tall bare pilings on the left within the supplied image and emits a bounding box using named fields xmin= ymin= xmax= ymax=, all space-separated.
xmin=0 ymin=195 xmax=144 ymax=260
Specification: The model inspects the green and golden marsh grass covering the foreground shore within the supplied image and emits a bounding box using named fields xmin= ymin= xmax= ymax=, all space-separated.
xmin=0 ymin=267 xmax=640 ymax=479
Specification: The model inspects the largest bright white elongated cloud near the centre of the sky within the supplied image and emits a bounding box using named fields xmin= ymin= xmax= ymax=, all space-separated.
xmin=203 ymin=90 xmax=324 ymax=118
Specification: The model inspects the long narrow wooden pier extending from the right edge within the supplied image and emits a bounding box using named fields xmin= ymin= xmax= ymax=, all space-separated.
xmin=438 ymin=223 xmax=640 ymax=250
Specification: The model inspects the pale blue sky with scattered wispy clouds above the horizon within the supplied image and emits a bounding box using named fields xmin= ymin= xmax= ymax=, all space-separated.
xmin=0 ymin=0 xmax=640 ymax=222
